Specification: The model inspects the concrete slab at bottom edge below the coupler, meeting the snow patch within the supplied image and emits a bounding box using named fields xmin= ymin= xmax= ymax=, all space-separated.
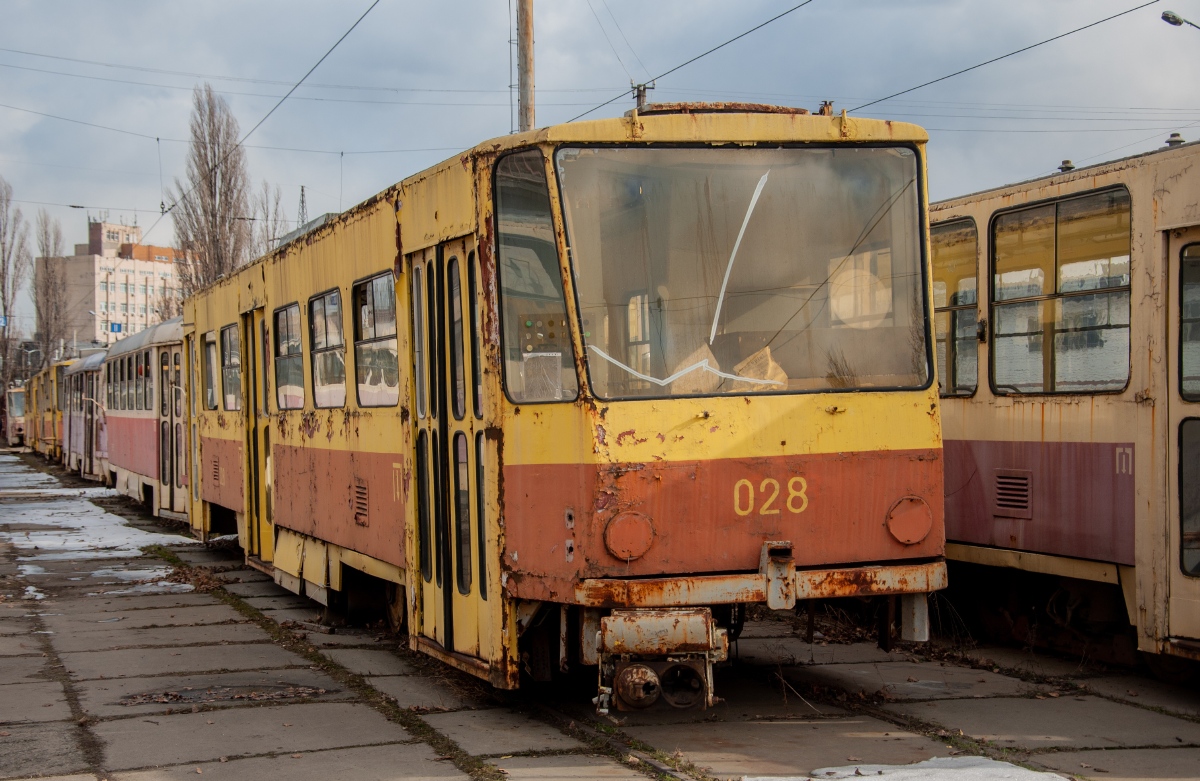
xmin=624 ymin=716 xmax=949 ymax=779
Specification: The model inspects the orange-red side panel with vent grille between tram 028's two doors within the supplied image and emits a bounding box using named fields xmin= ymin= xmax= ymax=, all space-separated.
xmin=271 ymin=445 xmax=408 ymax=566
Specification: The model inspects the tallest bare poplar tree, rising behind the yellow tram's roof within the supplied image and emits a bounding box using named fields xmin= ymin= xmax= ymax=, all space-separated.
xmin=173 ymin=84 xmax=253 ymax=295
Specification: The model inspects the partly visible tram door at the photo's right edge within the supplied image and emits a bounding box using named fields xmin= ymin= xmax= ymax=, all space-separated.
xmin=1165 ymin=227 xmax=1200 ymax=639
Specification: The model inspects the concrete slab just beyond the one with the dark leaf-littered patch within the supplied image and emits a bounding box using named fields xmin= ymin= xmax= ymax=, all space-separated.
xmin=60 ymin=644 xmax=308 ymax=680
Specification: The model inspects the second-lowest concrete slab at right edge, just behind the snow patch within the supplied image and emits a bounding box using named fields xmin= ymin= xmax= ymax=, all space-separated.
xmin=887 ymin=697 xmax=1200 ymax=750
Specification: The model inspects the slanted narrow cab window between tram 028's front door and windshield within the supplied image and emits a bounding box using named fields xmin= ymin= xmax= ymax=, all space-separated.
xmin=496 ymin=150 xmax=578 ymax=403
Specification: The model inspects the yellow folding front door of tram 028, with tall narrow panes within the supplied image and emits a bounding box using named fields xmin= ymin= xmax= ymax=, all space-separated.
xmin=409 ymin=236 xmax=496 ymax=659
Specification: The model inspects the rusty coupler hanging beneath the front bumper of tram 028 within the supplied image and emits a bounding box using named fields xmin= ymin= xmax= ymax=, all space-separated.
xmin=595 ymin=607 xmax=730 ymax=714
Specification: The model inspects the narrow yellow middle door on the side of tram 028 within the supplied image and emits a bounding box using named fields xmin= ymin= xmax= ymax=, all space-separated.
xmin=241 ymin=310 xmax=275 ymax=563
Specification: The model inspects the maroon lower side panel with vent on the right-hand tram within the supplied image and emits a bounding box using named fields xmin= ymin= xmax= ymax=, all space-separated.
xmin=944 ymin=439 xmax=1134 ymax=565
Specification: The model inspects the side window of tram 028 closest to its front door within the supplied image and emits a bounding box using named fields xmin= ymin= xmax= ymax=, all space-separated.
xmin=354 ymin=274 xmax=400 ymax=407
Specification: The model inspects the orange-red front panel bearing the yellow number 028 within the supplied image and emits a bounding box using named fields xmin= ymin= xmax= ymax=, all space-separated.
xmin=502 ymin=450 xmax=944 ymax=579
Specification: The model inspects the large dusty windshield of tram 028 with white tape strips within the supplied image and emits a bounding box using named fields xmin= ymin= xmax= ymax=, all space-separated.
xmin=556 ymin=146 xmax=930 ymax=398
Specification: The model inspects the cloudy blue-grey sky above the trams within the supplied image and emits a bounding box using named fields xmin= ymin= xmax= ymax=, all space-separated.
xmin=0 ymin=0 xmax=1200 ymax=330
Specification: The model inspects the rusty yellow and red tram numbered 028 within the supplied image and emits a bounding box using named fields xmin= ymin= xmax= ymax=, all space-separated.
xmin=184 ymin=104 xmax=946 ymax=708
